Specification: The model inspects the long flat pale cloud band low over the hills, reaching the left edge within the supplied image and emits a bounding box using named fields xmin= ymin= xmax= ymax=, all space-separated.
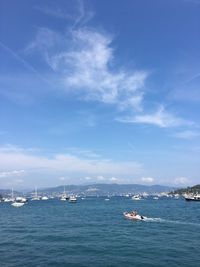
xmin=0 ymin=146 xmax=142 ymax=179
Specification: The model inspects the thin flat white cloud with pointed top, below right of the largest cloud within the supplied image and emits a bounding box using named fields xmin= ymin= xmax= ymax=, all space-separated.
xmin=117 ymin=106 xmax=192 ymax=128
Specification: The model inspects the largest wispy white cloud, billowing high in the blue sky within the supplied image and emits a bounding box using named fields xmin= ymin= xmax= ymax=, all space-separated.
xmin=26 ymin=28 xmax=148 ymax=110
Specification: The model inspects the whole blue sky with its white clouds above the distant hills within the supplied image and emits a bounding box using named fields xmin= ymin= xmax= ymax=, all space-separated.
xmin=0 ymin=0 xmax=200 ymax=188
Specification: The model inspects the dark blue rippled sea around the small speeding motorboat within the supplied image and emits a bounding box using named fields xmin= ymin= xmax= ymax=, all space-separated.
xmin=0 ymin=197 xmax=200 ymax=267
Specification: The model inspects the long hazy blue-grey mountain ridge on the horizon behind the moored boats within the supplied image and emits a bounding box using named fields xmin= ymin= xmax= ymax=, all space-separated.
xmin=30 ymin=184 xmax=176 ymax=196
